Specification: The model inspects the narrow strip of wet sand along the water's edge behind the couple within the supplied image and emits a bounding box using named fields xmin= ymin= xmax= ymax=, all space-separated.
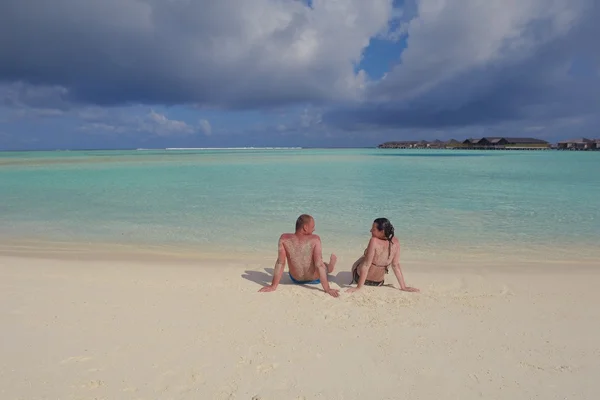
xmin=0 ymin=238 xmax=598 ymax=268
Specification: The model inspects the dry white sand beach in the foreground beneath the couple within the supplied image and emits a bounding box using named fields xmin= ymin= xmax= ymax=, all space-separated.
xmin=0 ymin=254 xmax=600 ymax=400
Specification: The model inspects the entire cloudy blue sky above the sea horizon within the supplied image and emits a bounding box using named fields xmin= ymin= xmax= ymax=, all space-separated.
xmin=0 ymin=0 xmax=600 ymax=150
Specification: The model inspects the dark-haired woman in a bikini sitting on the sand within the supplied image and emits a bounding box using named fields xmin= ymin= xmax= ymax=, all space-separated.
xmin=347 ymin=218 xmax=419 ymax=293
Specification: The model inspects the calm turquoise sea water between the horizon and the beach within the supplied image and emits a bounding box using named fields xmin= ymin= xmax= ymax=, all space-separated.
xmin=0 ymin=149 xmax=600 ymax=258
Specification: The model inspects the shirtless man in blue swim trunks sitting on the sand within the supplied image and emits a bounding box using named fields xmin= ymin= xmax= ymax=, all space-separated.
xmin=260 ymin=214 xmax=339 ymax=297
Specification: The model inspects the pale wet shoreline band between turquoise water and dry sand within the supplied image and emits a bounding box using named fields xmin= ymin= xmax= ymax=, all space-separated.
xmin=0 ymin=239 xmax=600 ymax=274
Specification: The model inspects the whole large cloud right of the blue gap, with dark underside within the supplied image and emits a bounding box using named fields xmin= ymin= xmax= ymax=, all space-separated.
xmin=323 ymin=0 xmax=600 ymax=134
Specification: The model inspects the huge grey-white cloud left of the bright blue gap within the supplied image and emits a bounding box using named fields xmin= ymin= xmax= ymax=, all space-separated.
xmin=0 ymin=0 xmax=392 ymax=107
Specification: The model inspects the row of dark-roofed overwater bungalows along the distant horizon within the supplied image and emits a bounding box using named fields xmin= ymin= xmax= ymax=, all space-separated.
xmin=377 ymin=137 xmax=600 ymax=150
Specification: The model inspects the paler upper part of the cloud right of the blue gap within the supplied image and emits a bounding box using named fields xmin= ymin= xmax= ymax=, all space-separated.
xmin=372 ymin=0 xmax=590 ymax=99
